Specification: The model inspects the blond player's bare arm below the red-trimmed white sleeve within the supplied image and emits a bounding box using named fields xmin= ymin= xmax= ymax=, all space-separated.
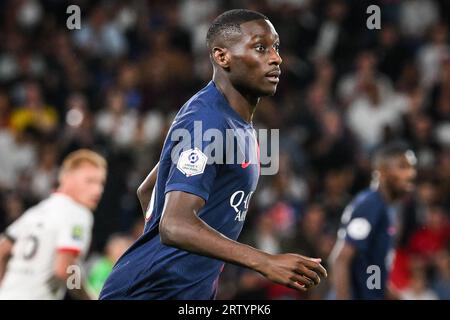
xmin=53 ymin=252 xmax=93 ymax=300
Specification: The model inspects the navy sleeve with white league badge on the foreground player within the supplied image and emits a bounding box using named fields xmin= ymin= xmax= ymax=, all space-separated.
xmin=165 ymin=109 xmax=225 ymax=201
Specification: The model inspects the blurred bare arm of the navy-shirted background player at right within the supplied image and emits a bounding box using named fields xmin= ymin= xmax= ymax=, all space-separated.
xmin=333 ymin=242 xmax=356 ymax=300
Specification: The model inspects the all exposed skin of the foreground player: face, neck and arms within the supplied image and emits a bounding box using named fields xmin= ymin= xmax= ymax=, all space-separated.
xmin=140 ymin=20 xmax=327 ymax=291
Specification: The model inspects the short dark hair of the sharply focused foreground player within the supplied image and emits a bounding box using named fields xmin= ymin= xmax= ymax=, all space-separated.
xmin=206 ymin=9 xmax=268 ymax=49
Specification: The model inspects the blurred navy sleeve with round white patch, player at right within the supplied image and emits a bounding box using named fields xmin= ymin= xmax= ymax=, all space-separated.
xmin=345 ymin=201 xmax=380 ymax=251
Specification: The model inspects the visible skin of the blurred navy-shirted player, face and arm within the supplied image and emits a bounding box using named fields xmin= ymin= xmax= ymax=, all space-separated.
xmin=333 ymin=153 xmax=417 ymax=300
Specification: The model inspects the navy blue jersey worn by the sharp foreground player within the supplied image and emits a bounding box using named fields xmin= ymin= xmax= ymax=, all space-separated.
xmin=100 ymin=81 xmax=260 ymax=299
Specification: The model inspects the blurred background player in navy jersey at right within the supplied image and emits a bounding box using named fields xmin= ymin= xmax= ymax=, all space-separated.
xmin=331 ymin=142 xmax=416 ymax=299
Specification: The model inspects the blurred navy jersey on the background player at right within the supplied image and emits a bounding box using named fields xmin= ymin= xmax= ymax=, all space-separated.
xmin=338 ymin=189 xmax=396 ymax=300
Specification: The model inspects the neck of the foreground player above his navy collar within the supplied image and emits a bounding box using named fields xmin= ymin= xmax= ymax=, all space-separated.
xmin=213 ymin=73 xmax=259 ymax=122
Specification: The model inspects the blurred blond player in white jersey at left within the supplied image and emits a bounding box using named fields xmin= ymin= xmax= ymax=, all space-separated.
xmin=0 ymin=149 xmax=106 ymax=300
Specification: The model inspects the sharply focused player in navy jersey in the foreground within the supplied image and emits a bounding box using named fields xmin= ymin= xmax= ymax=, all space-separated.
xmin=100 ymin=9 xmax=326 ymax=299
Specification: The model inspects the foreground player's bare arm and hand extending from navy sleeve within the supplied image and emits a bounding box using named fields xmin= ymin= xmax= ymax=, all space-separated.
xmin=159 ymin=191 xmax=326 ymax=291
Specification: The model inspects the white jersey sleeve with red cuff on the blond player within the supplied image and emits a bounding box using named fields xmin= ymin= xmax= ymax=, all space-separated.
xmin=56 ymin=212 xmax=92 ymax=255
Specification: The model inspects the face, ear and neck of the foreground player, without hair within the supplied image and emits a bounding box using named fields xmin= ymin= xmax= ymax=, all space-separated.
xmin=211 ymin=20 xmax=282 ymax=122
